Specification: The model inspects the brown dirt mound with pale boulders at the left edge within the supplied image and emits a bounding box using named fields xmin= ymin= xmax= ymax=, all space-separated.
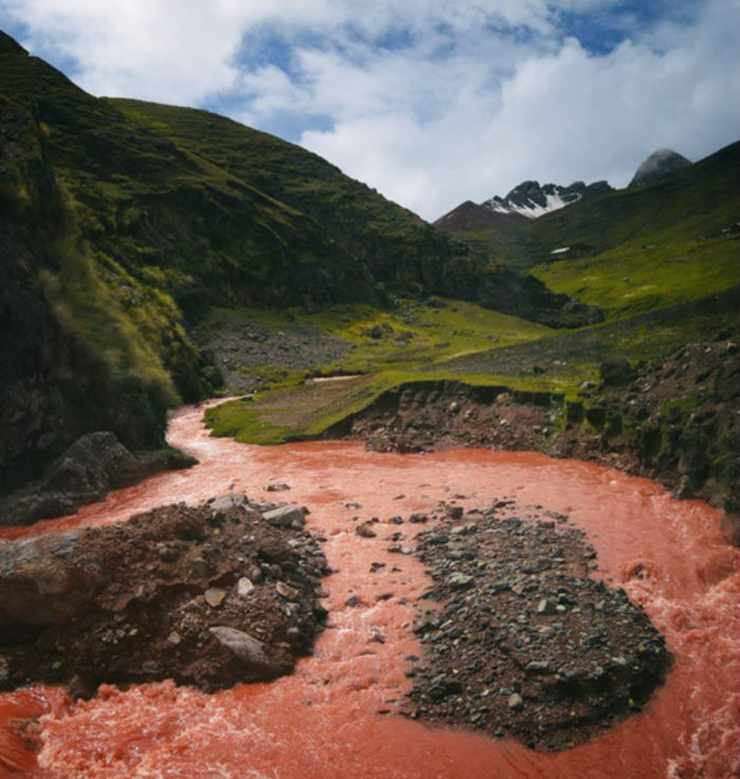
xmin=0 ymin=495 xmax=330 ymax=695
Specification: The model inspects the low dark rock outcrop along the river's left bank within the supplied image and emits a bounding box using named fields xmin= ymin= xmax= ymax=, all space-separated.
xmin=0 ymin=432 xmax=196 ymax=525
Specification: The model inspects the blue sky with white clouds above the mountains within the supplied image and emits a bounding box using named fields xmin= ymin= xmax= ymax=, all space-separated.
xmin=0 ymin=0 xmax=740 ymax=220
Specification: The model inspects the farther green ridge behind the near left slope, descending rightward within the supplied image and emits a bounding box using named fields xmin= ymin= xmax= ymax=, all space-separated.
xmin=108 ymin=99 xmax=596 ymax=327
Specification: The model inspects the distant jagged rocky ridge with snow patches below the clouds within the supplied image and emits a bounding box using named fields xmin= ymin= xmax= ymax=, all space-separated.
xmin=434 ymin=181 xmax=613 ymax=232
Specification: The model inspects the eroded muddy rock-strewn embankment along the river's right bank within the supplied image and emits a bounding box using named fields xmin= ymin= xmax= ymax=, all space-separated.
xmin=325 ymin=341 xmax=740 ymax=545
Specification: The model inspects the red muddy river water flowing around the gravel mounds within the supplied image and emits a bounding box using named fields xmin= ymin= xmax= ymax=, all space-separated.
xmin=0 ymin=408 xmax=740 ymax=779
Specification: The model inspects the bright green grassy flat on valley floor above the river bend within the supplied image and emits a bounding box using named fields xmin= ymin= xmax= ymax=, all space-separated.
xmin=202 ymin=301 xmax=556 ymax=444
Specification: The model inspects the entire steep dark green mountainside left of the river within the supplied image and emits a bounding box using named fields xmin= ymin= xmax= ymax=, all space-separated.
xmin=0 ymin=33 xmax=594 ymax=492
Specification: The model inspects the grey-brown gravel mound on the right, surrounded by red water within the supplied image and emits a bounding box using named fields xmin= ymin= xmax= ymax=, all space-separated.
xmin=407 ymin=501 xmax=670 ymax=749
